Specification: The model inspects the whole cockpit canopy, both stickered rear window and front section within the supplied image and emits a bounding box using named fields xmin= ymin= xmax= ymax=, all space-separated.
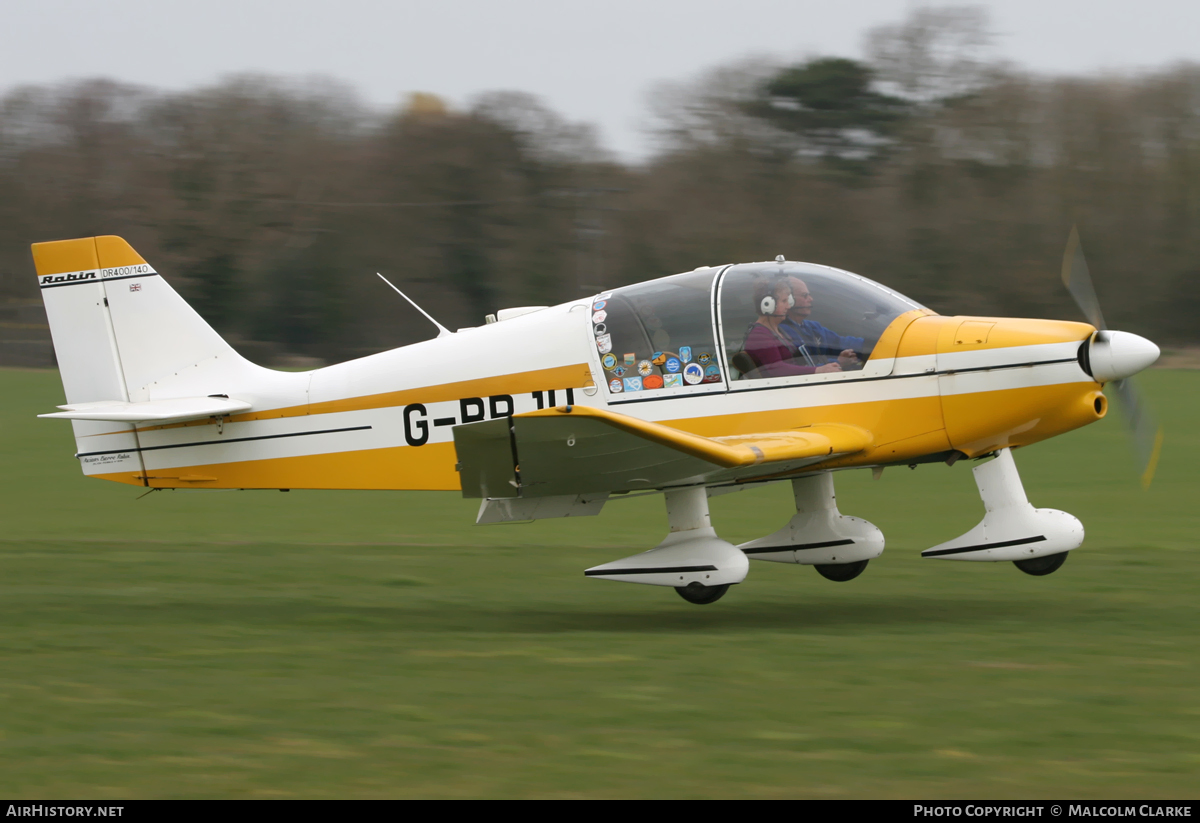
xmin=590 ymin=263 xmax=922 ymax=402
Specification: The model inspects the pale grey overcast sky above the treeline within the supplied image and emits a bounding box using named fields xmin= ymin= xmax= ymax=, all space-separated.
xmin=0 ymin=0 xmax=1200 ymax=158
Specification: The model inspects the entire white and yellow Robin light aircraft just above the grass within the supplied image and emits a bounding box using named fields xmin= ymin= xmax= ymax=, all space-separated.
xmin=32 ymin=232 xmax=1162 ymax=603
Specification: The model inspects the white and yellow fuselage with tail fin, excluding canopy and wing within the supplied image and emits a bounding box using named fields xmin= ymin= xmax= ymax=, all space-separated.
xmin=34 ymin=238 xmax=1106 ymax=491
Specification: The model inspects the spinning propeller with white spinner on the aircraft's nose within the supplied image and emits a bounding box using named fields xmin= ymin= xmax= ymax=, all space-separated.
xmin=1062 ymin=227 xmax=1163 ymax=488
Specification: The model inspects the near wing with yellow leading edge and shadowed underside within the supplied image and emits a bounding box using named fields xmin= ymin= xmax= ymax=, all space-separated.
xmin=454 ymin=406 xmax=871 ymax=498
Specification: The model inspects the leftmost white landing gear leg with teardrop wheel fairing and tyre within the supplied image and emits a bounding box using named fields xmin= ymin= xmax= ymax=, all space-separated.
xmin=583 ymin=486 xmax=750 ymax=605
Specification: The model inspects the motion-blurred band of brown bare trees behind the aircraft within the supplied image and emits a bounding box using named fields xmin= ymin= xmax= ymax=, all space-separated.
xmin=0 ymin=8 xmax=1200 ymax=360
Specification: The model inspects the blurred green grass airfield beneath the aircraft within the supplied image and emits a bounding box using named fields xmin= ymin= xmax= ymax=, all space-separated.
xmin=0 ymin=371 xmax=1200 ymax=798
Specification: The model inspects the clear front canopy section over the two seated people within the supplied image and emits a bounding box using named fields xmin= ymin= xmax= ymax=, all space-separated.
xmin=719 ymin=263 xmax=922 ymax=380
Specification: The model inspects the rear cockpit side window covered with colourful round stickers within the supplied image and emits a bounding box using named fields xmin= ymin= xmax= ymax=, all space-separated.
xmin=592 ymin=269 xmax=721 ymax=395
